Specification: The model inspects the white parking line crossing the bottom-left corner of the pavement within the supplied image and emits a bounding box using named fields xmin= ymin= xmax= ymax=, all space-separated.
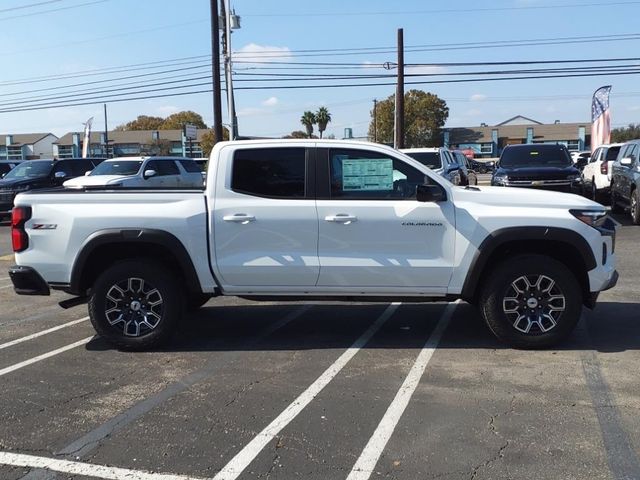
xmin=0 ymin=452 xmax=204 ymax=480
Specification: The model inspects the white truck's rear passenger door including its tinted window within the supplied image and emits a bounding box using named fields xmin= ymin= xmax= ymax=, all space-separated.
xmin=209 ymin=146 xmax=320 ymax=286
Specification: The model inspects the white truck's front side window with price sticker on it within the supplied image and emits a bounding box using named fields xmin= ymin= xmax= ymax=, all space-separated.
xmin=329 ymin=149 xmax=430 ymax=200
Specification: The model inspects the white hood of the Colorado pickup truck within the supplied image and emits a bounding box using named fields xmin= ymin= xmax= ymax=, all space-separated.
xmin=453 ymin=186 xmax=604 ymax=210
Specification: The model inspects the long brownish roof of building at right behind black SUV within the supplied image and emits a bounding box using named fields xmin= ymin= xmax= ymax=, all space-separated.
xmin=449 ymin=122 xmax=591 ymax=145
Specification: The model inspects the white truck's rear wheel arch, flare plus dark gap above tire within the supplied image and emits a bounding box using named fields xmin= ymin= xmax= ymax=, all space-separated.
xmin=68 ymin=229 xmax=208 ymax=296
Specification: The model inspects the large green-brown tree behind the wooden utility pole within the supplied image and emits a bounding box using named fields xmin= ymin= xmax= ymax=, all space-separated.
xmin=369 ymin=90 xmax=449 ymax=148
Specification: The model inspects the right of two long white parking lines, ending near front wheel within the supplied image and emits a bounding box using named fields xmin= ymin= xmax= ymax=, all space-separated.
xmin=347 ymin=301 xmax=459 ymax=480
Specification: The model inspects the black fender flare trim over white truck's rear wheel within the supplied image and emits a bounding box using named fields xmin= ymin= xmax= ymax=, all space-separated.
xmin=68 ymin=228 xmax=202 ymax=295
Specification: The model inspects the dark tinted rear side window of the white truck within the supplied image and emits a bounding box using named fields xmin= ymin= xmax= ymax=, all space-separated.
xmin=231 ymin=148 xmax=306 ymax=198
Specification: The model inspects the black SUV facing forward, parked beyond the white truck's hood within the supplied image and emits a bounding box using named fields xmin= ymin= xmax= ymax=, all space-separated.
xmin=491 ymin=144 xmax=581 ymax=193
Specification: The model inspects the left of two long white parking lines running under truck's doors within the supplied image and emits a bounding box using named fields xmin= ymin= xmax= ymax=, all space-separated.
xmin=213 ymin=303 xmax=400 ymax=480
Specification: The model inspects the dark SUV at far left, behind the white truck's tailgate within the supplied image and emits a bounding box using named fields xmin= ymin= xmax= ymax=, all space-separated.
xmin=0 ymin=158 xmax=104 ymax=219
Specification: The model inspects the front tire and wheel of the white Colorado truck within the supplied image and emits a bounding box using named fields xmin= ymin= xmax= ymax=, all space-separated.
xmin=480 ymin=255 xmax=582 ymax=349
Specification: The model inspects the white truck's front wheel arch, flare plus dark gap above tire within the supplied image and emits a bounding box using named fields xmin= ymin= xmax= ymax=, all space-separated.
xmin=462 ymin=227 xmax=597 ymax=304
